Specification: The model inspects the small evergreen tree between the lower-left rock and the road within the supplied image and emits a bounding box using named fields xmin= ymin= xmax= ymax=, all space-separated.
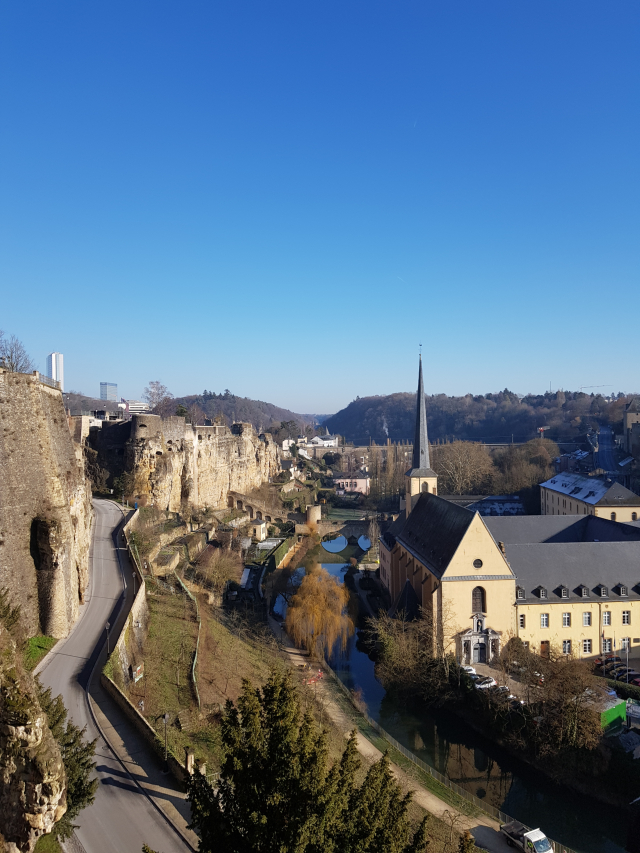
xmin=39 ymin=687 xmax=98 ymax=840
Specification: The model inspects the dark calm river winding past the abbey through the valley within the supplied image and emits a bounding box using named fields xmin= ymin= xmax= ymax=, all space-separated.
xmin=323 ymin=563 xmax=628 ymax=853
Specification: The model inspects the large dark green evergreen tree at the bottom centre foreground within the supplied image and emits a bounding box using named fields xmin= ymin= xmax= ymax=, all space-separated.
xmin=189 ymin=672 xmax=427 ymax=853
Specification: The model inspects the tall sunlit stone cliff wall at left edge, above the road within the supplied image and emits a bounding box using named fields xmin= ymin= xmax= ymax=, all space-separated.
xmin=0 ymin=369 xmax=93 ymax=637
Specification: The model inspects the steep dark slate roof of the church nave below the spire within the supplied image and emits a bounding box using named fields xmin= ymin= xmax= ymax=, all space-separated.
xmin=396 ymin=492 xmax=475 ymax=579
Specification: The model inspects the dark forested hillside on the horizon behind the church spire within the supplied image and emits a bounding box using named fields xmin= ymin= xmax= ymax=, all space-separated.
xmin=323 ymin=389 xmax=630 ymax=444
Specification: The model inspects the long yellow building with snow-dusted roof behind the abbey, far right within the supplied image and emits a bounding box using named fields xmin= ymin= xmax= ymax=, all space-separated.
xmin=540 ymin=471 xmax=640 ymax=521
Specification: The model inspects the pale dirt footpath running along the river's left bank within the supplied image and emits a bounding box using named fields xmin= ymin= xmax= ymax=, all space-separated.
xmin=269 ymin=617 xmax=509 ymax=853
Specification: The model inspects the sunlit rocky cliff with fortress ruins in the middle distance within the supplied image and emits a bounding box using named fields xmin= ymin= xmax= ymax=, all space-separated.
xmin=92 ymin=415 xmax=280 ymax=517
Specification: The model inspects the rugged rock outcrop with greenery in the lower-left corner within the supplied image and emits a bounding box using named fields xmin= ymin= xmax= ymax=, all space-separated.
xmin=0 ymin=624 xmax=67 ymax=853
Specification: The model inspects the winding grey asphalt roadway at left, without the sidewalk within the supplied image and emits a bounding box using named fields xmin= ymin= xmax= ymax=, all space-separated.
xmin=40 ymin=500 xmax=190 ymax=853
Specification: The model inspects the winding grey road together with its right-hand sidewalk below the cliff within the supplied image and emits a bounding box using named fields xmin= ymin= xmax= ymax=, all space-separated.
xmin=37 ymin=500 xmax=197 ymax=853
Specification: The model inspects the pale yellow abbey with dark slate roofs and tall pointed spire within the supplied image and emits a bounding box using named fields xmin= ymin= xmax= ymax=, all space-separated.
xmin=380 ymin=362 xmax=640 ymax=664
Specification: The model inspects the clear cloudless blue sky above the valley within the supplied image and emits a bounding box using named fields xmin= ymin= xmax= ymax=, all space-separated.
xmin=0 ymin=0 xmax=640 ymax=413
